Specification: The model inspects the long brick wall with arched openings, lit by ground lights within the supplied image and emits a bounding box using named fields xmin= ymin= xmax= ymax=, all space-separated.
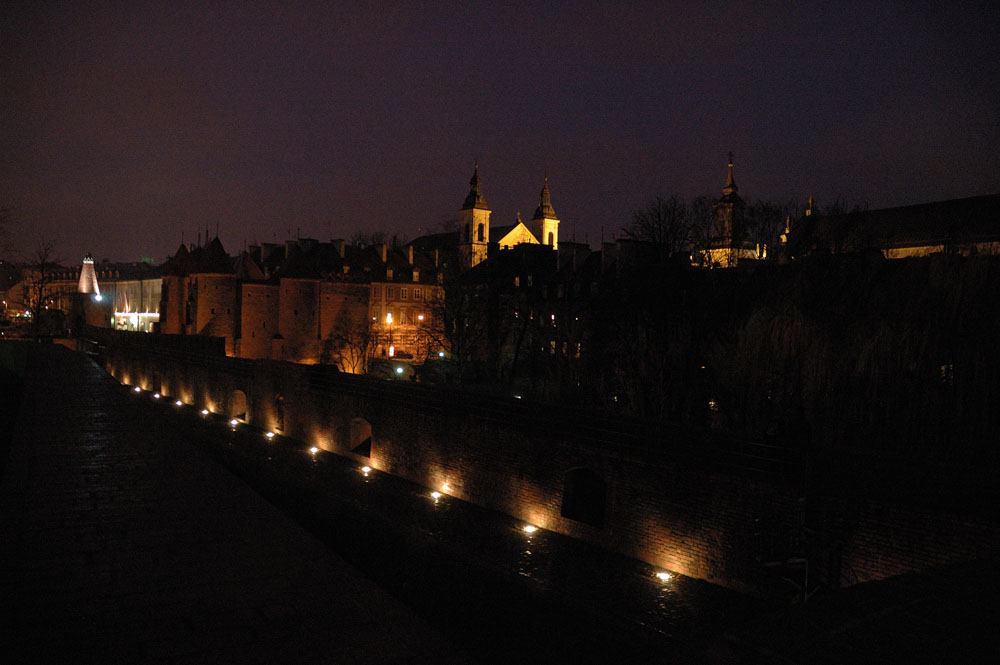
xmin=99 ymin=347 xmax=1000 ymax=590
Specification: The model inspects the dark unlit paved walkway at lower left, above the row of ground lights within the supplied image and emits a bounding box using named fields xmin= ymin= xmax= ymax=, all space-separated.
xmin=0 ymin=346 xmax=470 ymax=664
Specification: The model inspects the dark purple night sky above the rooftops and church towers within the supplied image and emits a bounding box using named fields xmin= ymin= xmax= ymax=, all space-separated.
xmin=0 ymin=0 xmax=1000 ymax=264
